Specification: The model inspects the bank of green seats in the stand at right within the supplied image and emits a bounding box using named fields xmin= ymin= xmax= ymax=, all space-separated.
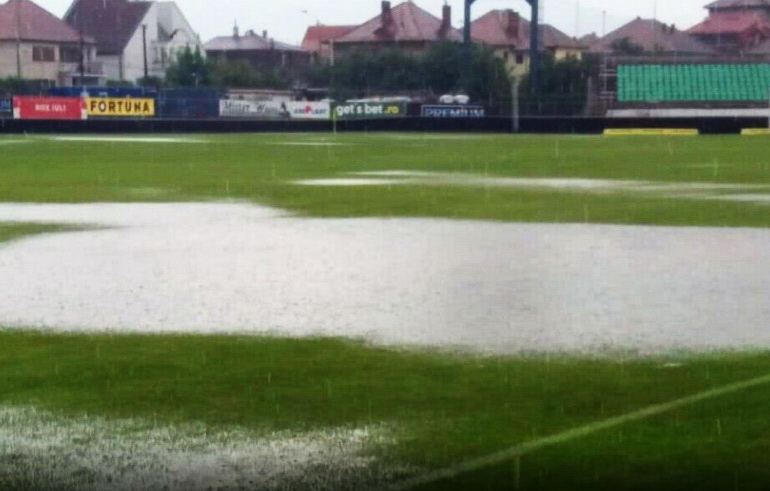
xmin=617 ymin=63 xmax=770 ymax=103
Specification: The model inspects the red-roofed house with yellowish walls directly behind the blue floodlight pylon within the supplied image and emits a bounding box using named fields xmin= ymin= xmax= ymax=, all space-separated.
xmin=471 ymin=10 xmax=586 ymax=77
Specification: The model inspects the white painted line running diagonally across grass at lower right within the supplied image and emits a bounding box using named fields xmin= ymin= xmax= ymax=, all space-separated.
xmin=389 ymin=375 xmax=770 ymax=491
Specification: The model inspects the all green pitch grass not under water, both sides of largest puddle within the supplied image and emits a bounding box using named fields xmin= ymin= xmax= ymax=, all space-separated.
xmin=0 ymin=135 xmax=770 ymax=490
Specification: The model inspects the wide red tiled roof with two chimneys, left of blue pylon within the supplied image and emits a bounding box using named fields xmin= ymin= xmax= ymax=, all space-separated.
xmin=336 ymin=1 xmax=462 ymax=43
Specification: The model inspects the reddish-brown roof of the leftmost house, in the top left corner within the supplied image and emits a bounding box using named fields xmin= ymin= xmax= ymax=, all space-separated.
xmin=0 ymin=0 xmax=86 ymax=43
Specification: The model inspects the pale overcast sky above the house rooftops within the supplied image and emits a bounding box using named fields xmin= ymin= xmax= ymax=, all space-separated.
xmin=33 ymin=0 xmax=710 ymax=44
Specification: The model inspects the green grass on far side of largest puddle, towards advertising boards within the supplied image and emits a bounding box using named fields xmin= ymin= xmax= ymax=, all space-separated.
xmin=0 ymin=134 xmax=770 ymax=227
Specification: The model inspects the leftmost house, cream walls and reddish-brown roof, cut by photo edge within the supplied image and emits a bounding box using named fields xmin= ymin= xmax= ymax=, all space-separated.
xmin=0 ymin=0 xmax=103 ymax=85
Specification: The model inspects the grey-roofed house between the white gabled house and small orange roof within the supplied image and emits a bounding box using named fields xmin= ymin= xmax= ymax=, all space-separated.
xmin=204 ymin=26 xmax=311 ymax=76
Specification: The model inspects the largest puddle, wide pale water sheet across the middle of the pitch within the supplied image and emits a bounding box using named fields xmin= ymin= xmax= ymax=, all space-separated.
xmin=0 ymin=204 xmax=770 ymax=353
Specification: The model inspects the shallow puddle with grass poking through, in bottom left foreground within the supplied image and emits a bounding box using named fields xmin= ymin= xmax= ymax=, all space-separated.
xmin=0 ymin=406 xmax=400 ymax=491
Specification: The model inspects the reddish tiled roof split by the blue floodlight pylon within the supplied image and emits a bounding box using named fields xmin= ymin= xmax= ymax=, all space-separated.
xmin=471 ymin=10 xmax=580 ymax=50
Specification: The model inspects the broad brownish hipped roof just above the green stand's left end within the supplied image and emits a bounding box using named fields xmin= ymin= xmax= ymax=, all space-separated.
xmin=591 ymin=17 xmax=714 ymax=55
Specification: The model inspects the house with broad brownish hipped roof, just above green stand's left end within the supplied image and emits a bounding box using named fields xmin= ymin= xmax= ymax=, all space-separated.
xmin=590 ymin=17 xmax=714 ymax=57
